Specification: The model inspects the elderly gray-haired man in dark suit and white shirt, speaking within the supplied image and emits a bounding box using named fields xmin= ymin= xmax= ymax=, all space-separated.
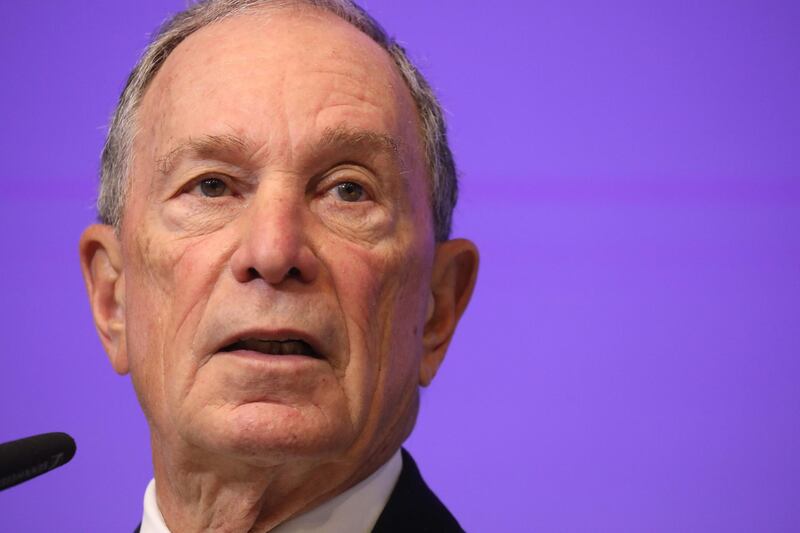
xmin=80 ymin=0 xmax=478 ymax=533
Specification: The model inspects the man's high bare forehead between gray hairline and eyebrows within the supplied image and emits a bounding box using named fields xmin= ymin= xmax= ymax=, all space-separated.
xmin=135 ymin=8 xmax=421 ymax=159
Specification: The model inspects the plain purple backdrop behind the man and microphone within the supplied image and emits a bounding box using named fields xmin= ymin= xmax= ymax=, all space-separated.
xmin=0 ymin=0 xmax=800 ymax=532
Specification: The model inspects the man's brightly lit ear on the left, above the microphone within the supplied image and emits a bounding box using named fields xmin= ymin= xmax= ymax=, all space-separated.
xmin=80 ymin=224 xmax=129 ymax=374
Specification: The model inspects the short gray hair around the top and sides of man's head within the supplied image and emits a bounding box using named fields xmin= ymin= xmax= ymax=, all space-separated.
xmin=97 ymin=0 xmax=458 ymax=242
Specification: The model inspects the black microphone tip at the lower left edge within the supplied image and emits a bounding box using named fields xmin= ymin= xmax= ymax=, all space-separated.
xmin=0 ymin=433 xmax=75 ymax=490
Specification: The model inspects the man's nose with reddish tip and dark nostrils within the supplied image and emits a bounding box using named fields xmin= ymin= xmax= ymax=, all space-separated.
xmin=231 ymin=188 xmax=319 ymax=285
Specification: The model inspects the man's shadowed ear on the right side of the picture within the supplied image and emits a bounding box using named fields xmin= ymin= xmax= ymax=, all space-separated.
xmin=419 ymin=239 xmax=478 ymax=387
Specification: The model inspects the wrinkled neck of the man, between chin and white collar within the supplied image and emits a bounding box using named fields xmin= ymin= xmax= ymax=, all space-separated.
xmin=148 ymin=438 xmax=395 ymax=533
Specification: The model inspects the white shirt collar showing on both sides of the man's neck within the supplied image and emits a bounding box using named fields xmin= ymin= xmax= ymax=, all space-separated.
xmin=140 ymin=450 xmax=403 ymax=533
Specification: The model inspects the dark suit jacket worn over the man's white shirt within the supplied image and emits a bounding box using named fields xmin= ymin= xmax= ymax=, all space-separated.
xmin=133 ymin=450 xmax=464 ymax=533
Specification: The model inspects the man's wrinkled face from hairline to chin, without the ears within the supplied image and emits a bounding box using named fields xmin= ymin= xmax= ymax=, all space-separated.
xmin=115 ymin=11 xmax=435 ymax=461
